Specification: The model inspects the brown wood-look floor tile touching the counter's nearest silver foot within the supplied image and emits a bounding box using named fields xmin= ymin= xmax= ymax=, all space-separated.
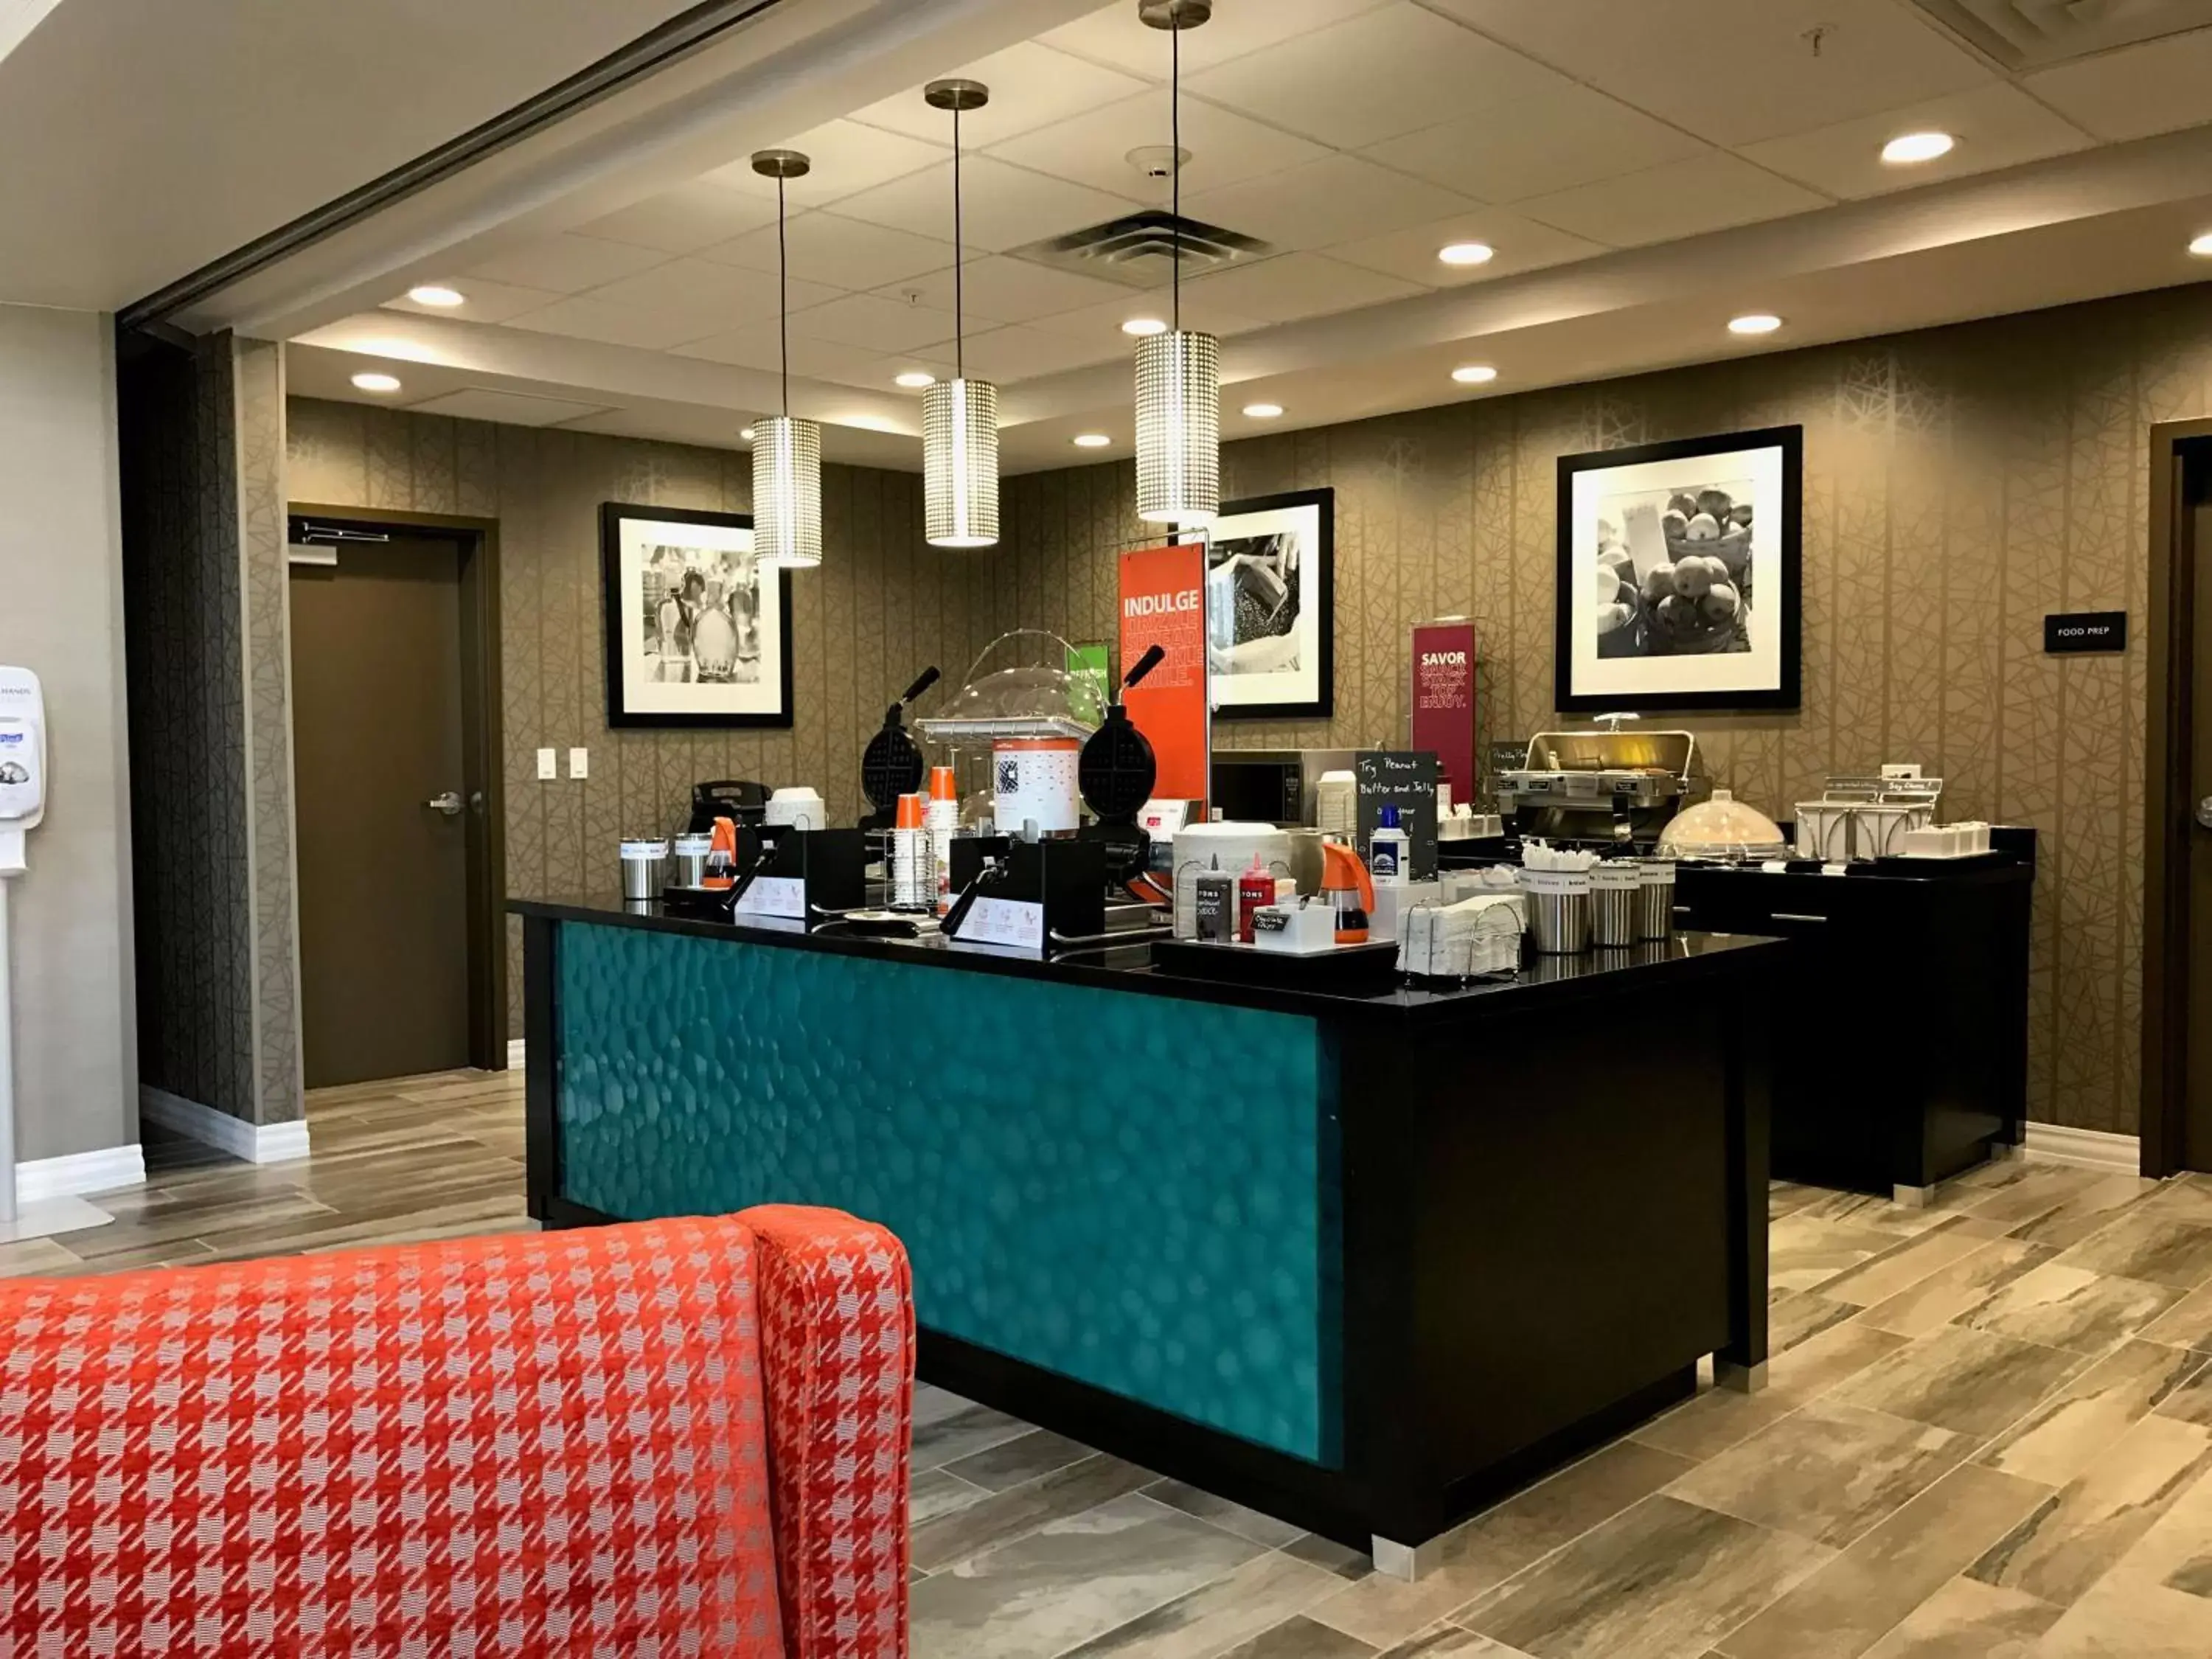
xmin=1310 ymin=1440 xmax=1690 ymax=1648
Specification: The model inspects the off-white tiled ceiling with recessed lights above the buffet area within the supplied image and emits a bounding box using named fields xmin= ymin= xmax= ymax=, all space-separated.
xmin=259 ymin=0 xmax=2212 ymax=467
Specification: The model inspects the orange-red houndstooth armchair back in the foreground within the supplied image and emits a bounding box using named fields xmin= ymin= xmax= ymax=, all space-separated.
xmin=0 ymin=1206 xmax=914 ymax=1659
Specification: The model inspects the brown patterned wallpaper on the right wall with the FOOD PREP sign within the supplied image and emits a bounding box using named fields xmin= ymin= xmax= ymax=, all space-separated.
xmin=1009 ymin=288 xmax=2212 ymax=1133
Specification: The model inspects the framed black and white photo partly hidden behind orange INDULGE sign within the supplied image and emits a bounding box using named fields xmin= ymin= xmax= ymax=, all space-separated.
xmin=1206 ymin=489 xmax=1336 ymax=719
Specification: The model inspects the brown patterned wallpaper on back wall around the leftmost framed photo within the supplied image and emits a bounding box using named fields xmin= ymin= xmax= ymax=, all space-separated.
xmin=288 ymin=398 xmax=993 ymax=1035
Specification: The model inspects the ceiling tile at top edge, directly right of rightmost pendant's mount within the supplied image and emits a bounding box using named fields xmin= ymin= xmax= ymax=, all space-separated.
xmin=1183 ymin=0 xmax=1562 ymax=148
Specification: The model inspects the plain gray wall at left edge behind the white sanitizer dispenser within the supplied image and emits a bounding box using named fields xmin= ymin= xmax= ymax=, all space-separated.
xmin=0 ymin=305 xmax=137 ymax=1159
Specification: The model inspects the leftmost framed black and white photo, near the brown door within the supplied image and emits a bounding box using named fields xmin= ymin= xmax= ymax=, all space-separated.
xmin=599 ymin=502 xmax=792 ymax=726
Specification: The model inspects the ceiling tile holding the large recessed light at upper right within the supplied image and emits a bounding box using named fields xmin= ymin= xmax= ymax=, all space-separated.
xmin=1743 ymin=82 xmax=2090 ymax=197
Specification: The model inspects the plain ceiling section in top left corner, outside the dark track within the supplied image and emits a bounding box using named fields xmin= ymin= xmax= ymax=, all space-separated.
xmin=0 ymin=0 xmax=690 ymax=310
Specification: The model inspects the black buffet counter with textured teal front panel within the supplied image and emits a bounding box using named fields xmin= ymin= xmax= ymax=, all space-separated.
xmin=511 ymin=900 xmax=1794 ymax=1573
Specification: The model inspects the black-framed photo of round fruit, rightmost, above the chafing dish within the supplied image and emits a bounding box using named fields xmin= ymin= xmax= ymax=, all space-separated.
xmin=1557 ymin=427 xmax=1805 ymax=714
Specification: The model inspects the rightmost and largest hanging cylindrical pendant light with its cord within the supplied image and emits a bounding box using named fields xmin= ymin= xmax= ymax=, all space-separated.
xmin=1137 ymin=0 xmax=1221 ymax=524
